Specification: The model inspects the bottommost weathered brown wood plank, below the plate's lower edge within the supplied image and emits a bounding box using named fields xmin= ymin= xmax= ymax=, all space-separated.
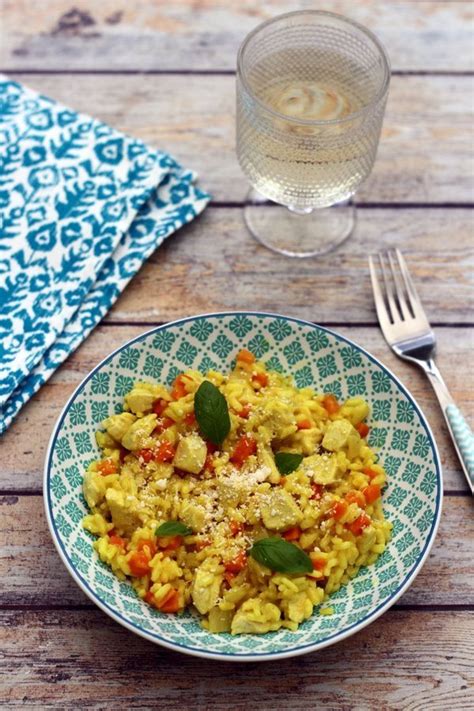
xmin=1 ymin=610 xmax=474 ymax=711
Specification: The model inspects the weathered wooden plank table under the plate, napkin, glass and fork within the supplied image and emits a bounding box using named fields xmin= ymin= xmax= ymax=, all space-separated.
xmin=0 ymin=0 xmax=474 ymax=711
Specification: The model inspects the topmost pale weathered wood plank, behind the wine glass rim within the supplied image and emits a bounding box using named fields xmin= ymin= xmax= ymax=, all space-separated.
xmin=0 ymin=0 xmax=472 ymax=71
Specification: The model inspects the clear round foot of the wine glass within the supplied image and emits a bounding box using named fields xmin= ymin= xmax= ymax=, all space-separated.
xmin=244 ymin=189 xmax=356 ymax=258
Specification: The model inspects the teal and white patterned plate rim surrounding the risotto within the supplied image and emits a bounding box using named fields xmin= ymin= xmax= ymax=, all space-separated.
xmin=44 ymin=311 xmax=442 ymax=661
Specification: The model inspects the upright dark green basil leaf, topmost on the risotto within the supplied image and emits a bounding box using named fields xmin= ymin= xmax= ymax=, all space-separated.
xmin=194 ymin=380 xmax=230 ymax=445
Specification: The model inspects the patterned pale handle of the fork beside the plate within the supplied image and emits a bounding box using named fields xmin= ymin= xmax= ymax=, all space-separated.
xmin=420 ymin=359 xmax=474 ymax=494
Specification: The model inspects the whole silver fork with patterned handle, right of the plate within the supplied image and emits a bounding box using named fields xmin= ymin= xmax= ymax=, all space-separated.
xmin=369 ymin=249 xmax=474 ymax=494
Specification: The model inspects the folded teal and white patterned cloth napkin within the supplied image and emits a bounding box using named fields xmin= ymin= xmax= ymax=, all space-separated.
xmin=0 ymin=75 xmax=210 ymax=434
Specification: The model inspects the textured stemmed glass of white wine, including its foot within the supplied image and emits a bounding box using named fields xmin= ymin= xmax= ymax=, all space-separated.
xmin=237 ymin=10 xmax=390 ymax=257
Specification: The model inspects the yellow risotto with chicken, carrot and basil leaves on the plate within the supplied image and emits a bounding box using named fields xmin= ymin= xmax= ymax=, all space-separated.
xmin=83 ymin=350 xmax=391 ymax=634
